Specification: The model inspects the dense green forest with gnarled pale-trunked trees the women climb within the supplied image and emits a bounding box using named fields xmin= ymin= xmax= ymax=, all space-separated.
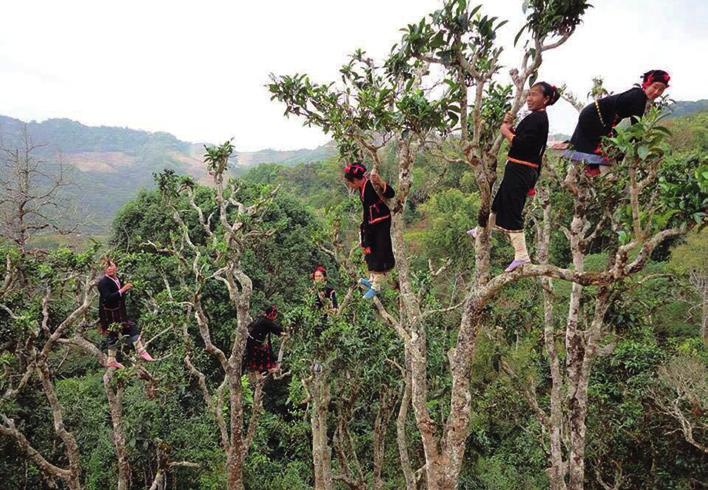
xmin=0 ymin=0 xmax=708 ymax=490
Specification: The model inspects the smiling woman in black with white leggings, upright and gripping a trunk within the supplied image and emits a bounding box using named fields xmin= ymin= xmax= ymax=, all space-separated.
xmin=467 ymin=82 xmax=560 ymax=272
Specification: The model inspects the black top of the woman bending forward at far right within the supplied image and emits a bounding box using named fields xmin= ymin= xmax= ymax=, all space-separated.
xmin=570 ymin=87 xmax=647 ymax=154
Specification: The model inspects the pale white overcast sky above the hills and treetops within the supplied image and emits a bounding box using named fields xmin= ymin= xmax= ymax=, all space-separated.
xmin=0 ymin=0 xmax=708 ymax=151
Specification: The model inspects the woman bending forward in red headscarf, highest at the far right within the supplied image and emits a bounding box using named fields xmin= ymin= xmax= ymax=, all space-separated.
xmin=563 ymin=70 xmax=671 ymax=177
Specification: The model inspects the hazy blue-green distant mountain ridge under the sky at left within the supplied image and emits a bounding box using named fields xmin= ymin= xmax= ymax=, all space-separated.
xmin=0 ymin=116 xmax=336 ymax=233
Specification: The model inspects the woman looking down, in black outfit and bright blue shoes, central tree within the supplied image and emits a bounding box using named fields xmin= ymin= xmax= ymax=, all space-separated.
xmin=344 ymin=163 xmax=396 ymax=299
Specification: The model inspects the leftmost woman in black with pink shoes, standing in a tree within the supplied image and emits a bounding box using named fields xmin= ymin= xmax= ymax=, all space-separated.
xmin=98 ymin=257 xmax=154 ymax=369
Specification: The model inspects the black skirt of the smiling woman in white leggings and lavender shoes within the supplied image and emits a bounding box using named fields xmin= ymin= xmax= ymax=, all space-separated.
xmin=492 ymin=161 xmax=538 ymax=231
